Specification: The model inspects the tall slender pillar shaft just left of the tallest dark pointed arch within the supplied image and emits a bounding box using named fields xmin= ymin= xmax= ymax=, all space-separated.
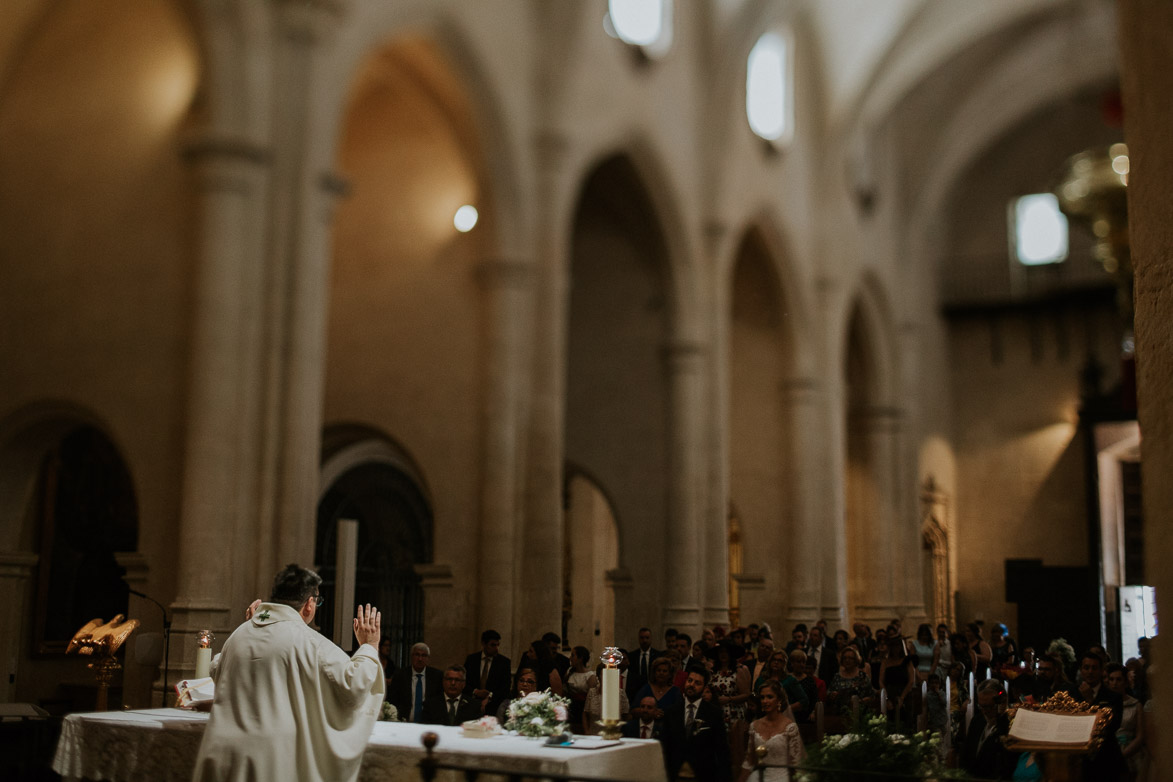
xmin=520 ymin=132 xmax=571 ymax=657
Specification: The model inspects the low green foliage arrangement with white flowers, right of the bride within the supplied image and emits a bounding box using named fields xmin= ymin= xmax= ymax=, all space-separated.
xmin=798 ymin=716 xmax=964 ymax=782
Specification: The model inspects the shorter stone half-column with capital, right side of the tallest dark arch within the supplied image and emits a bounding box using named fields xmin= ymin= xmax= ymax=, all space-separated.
xmin=663 ymin=341 xmax=699 ymax=637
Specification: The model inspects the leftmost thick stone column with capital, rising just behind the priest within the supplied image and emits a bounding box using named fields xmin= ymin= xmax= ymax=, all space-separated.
xmin=171 ymin=135 xmax=265 ymax=673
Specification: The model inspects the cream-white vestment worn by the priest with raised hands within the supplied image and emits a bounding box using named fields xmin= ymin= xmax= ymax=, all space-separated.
xmin=192 ymin=603 xmax=384 ymax=782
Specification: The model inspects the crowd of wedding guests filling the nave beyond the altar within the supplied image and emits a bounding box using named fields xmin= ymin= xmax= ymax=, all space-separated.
xmin=380 ymin=619 xmax=1152 ymax=782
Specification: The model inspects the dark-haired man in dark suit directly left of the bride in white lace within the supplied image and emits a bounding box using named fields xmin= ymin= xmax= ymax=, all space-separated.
xmin=662 ymin=665 xmax=730 ymax=782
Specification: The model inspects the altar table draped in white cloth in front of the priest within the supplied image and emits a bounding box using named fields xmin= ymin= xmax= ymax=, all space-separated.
xmin=53 ymin=708 xmax=665 ymax=782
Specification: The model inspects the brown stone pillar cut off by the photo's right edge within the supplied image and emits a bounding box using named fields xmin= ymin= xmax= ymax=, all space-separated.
xmin=1118 ymin=0 xmax=1173 ymax=780
